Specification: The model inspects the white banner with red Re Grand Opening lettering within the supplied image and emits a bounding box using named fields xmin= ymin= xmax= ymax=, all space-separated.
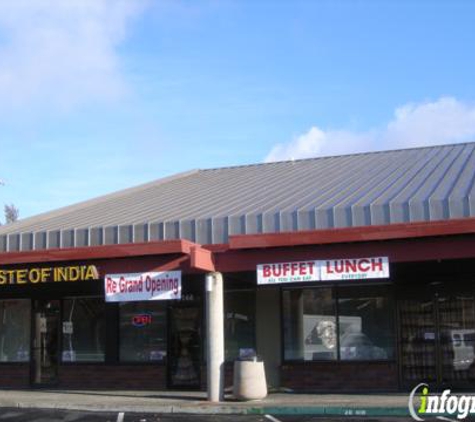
xmin=104 ymin=271 xmax=181 ymax=302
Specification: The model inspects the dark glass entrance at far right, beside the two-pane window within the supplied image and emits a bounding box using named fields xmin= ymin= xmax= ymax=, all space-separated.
xmin=397 ymin=260 xmax=475 ymax=390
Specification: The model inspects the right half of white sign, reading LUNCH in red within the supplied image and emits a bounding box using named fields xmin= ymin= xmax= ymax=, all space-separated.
xmin=320 ymin=257 xmax=389 ymax=280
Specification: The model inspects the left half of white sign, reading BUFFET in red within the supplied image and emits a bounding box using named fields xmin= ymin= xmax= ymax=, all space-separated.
xmin=257 ymin=261 xmax=320 ymax=284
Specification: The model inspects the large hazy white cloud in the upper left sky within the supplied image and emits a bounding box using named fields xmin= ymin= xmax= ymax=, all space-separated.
xmin=0 ymin=0 xmax=145 ymax=108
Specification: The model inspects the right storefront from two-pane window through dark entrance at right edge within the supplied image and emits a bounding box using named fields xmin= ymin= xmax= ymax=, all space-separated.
xmin=268 ymin=260 xmax=475 ymax=392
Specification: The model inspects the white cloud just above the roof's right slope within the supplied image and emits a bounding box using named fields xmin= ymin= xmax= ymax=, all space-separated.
xmin=265 ymin=97 xmax=475 ymax=162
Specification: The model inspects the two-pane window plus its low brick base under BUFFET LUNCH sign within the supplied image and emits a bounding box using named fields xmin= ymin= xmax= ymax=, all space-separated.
xmin=282 ymin=280 xmax=398 ymax=391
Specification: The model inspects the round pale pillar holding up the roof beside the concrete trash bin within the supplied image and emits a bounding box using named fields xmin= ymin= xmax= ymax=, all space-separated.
xmin=206 ymin=273 xmax=224 ymax=402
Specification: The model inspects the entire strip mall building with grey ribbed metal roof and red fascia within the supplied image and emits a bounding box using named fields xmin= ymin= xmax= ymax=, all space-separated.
xmin=0 ymin=143 xmax=475 ymax=391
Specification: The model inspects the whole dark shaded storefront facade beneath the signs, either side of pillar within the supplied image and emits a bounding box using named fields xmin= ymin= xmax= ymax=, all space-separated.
xmin=0 ymin=254 xmax=475 ymax=391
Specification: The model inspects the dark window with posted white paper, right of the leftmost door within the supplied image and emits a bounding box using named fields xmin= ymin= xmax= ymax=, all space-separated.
xmin=62 ymin=298 xmax=105 ymax=362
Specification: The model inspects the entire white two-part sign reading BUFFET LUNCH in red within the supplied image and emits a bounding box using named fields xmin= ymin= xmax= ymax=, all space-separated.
xmin=257 ymin=257 xmax=389 ymax=285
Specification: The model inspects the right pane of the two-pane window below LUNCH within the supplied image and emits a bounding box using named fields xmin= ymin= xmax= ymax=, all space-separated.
xmin=338 ymin=286 xmax=394 ymax=360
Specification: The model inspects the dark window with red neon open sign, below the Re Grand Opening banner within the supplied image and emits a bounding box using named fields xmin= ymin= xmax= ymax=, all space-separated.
xmin=119 ymin=302 xmax=167 ymax=362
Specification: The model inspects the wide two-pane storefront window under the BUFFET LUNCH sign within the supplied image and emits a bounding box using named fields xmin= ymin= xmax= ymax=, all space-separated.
xmin=283 ymin=286 xmax=394 ymax=360
